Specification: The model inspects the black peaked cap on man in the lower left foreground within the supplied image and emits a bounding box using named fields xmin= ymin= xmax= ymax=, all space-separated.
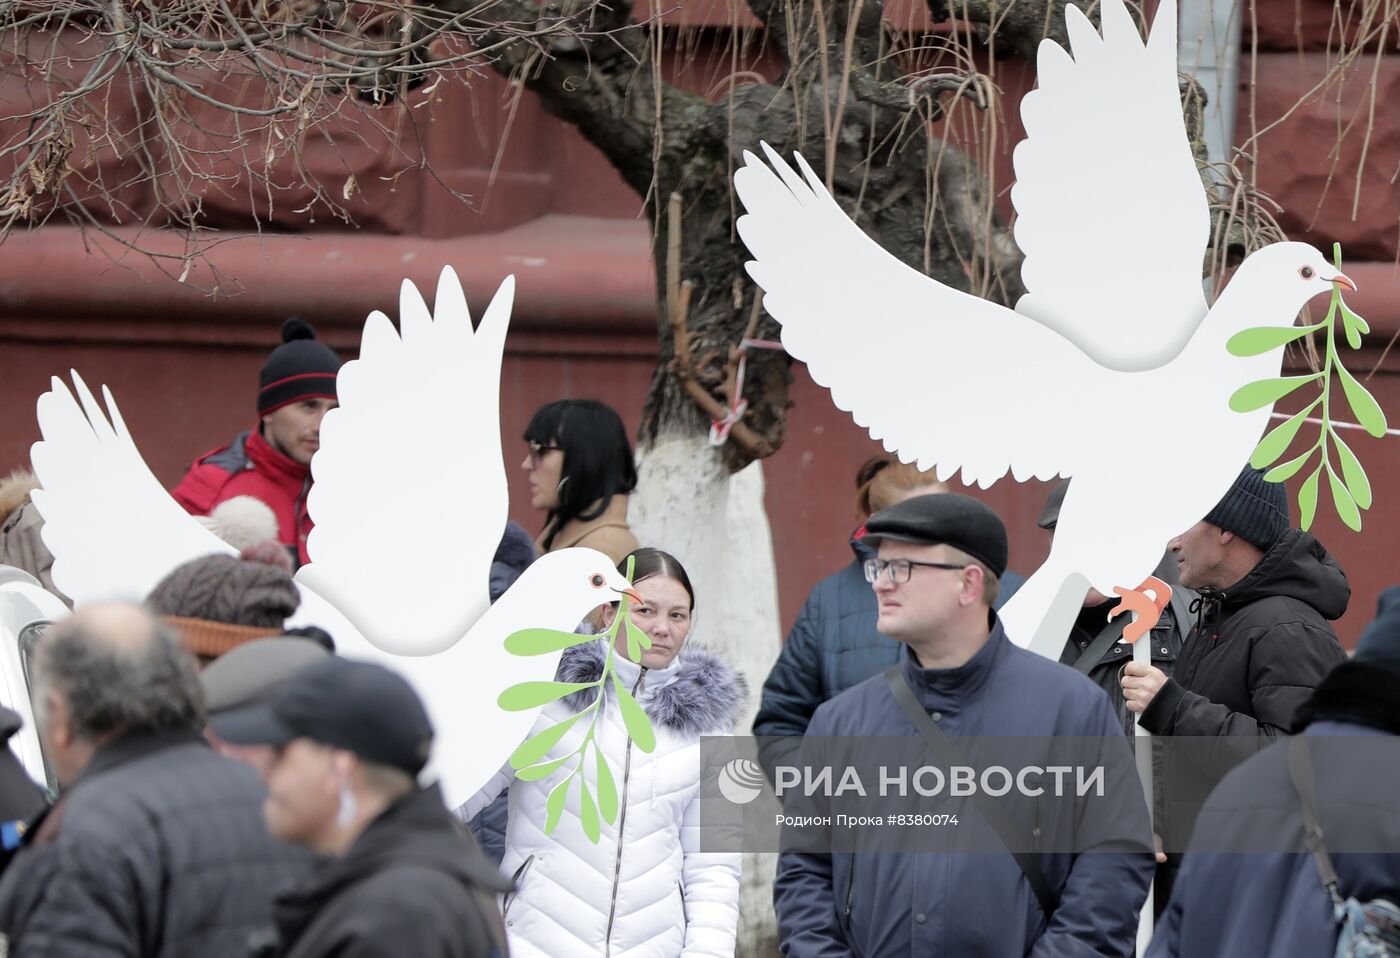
xmin=209 ymin=657 xmax=433 ymax=776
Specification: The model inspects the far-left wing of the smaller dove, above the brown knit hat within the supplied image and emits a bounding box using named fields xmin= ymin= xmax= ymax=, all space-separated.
xmin=29 ymin=373 xmax=235 ymax=604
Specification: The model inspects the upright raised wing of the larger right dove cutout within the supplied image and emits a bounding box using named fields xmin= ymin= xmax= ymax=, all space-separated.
xmin=1011 ymin=0 xmax=1210 ymax=370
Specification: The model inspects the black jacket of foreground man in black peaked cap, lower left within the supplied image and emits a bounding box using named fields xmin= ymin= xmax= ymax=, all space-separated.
xmin=260 ymin=786 xmax=510 ymax=958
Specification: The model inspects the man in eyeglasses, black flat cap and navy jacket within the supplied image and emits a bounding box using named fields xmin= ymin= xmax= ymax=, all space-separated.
xmin=774 ymin=493 xmax=1152 ymax=958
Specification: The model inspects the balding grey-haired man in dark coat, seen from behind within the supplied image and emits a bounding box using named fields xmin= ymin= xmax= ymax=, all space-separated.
xmin=0 ymin=604 xmax=307 ymax=958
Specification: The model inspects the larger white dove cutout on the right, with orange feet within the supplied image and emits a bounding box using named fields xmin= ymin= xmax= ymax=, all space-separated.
xmin=734 ymin=0 xmax=1355 ymax=658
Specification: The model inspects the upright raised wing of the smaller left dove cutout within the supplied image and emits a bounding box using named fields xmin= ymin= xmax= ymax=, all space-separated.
xmin=297 ymin=268 xmax=515 ymax=655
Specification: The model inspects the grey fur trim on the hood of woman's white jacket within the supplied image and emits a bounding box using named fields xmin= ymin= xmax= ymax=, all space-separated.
xmin=556 ymin=639 xmax=749 ymax=735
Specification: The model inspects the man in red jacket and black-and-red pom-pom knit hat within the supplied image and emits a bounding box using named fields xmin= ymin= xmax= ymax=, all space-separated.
xmin=171 ymin=319 xmax=340 ymax=566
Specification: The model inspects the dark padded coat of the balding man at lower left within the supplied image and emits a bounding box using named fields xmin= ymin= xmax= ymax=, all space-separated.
xmin=0 ymin=728 xmax=309 ymax=958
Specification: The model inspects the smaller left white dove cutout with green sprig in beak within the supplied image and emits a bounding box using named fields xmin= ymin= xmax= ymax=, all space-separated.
xmin=31 ymin=268 xmax=641 ymax=807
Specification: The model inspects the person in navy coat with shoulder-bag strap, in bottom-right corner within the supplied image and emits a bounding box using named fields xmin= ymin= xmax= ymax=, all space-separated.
xmin=1148 ymin=587 xmax=1400 ymax=958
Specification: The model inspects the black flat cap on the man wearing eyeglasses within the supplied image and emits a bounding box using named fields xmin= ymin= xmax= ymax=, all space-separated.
xmin=865 ymin=493 xmax=1007 ymax=578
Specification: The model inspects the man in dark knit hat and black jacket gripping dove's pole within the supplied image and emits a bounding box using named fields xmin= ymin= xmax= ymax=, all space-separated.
xmin=1121 ymin=466 xmax=1351 ymax=902
